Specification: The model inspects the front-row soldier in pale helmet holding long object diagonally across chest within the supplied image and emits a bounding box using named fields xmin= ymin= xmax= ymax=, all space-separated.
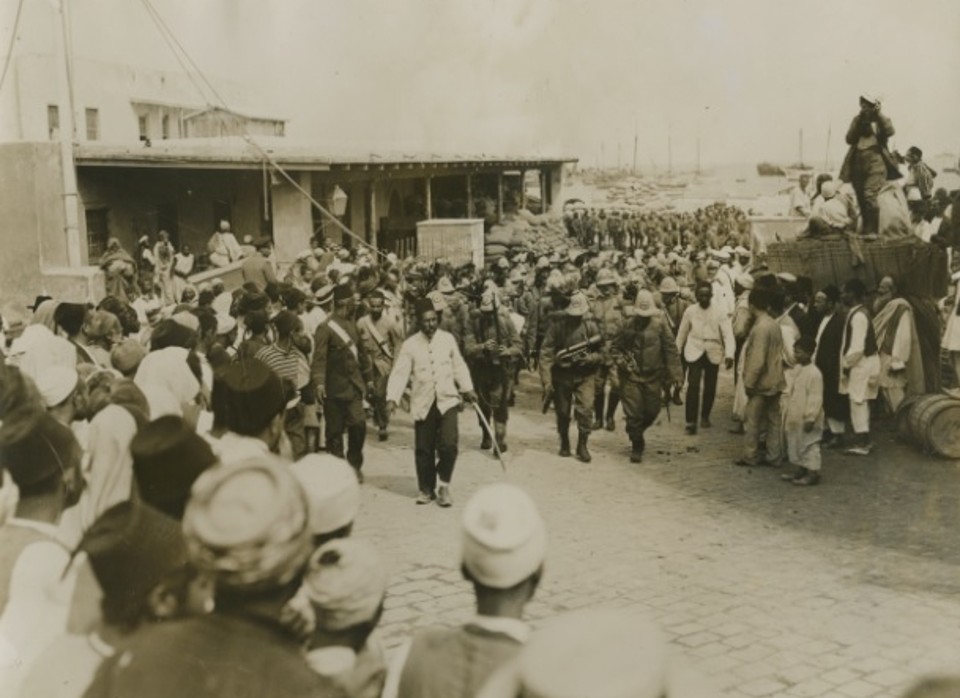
xmin=540 ymin=292 xmax=601 ymax=463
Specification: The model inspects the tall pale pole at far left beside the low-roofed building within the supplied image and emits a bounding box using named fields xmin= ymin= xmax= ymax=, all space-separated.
xmin=53 ymin=0 xmax=83 ymax=267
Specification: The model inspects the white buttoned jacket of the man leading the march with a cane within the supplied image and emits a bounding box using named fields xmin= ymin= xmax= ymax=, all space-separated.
xmin=387 ymin=329 xmax=473 ymax=421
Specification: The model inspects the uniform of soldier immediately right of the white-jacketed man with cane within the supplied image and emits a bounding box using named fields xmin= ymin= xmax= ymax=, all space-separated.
xmin=466 ymin=306 xmax=521 ymax=451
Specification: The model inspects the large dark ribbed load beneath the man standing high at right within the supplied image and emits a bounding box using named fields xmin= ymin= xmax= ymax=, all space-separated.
xmin=767 ymin=238 xmax=949 ymax=298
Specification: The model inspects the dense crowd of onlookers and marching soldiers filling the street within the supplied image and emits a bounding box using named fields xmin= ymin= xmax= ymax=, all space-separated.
xmin=0 ymin=92 xmax=960 ymax=698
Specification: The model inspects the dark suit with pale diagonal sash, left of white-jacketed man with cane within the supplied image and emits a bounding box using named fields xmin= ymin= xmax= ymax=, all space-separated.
xmin=310 ymin=317 xmax=371 ymax=470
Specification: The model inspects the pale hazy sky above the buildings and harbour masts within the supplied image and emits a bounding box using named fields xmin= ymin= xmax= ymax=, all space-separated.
xmin=7 ymin=0 xmax=960 ymax=166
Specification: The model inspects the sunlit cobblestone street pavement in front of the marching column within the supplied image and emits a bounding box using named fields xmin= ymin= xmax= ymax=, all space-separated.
xmin=356 ymin=376 xmax=960 ymax=698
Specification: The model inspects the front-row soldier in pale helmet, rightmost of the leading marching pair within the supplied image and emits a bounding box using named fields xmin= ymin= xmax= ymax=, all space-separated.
xmin=613 ymin=291 xmax=682 ymax=462
